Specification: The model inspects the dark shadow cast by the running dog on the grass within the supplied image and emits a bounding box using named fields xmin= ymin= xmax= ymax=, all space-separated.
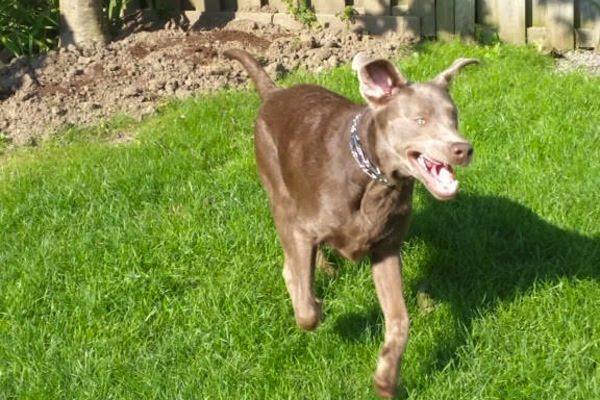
xmin=334 ymin=192 xmax=600 ymax=372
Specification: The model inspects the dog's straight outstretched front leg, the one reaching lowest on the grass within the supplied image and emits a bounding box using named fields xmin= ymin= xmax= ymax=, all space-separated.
xmin=373 ymin=251 xmax=410 ymax=397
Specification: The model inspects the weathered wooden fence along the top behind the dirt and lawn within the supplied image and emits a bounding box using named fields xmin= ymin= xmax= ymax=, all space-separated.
xmin=142 ymin=0 xmax=600 ymax=50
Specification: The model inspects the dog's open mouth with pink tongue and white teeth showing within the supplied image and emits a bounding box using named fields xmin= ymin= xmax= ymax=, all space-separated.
xmin=409 ymin=153 xmax=458 ymax=200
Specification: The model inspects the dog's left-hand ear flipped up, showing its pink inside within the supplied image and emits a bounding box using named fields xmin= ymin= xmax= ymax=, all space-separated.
xmin=352 ymin=53 xmax=407 ymax=104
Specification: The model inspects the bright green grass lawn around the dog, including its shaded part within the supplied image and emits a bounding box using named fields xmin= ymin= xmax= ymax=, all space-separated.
xmin=0 ymin=43 xmax=600 ymax=400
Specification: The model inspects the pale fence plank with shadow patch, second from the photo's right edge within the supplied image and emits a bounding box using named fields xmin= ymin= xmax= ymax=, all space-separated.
xmin=546 ymin=0 xmax=575 ymax=50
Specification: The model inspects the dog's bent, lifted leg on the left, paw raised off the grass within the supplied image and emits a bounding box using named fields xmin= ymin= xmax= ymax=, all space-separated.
xmin=281 ymin=229 xmax=321 ymax=330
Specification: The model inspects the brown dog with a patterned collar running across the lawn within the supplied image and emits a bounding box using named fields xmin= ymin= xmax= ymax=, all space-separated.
xmin=225 ymin=49 xmax=477 ymax=397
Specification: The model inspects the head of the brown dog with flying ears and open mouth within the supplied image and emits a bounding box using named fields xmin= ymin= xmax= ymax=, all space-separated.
xmin=352 ymin=53 xmax=478 ymax=200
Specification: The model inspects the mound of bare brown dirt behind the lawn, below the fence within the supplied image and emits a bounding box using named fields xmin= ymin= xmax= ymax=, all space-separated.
xmin=0 ymin=21 xmax=406 ymax=146
